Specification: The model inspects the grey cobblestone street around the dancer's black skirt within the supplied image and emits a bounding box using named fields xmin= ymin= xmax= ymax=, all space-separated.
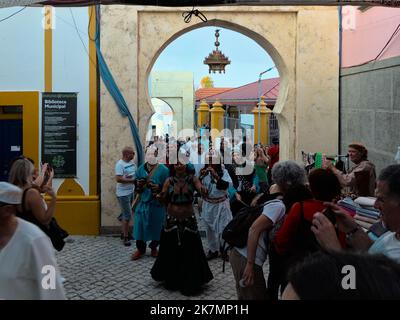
xmin=57 ymin=236 xmax=267 ymax=300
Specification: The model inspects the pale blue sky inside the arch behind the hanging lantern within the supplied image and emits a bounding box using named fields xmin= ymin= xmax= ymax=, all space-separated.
xmin=152 ymin=27 xmax=279 ymax=89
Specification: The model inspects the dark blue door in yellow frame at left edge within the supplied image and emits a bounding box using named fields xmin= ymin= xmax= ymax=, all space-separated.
xmin=0 ymin=120 xmax=23 ymax=181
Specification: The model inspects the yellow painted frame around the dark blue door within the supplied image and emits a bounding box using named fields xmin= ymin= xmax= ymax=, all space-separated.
xmin=0 ymin=91 xmax=39 ymax=164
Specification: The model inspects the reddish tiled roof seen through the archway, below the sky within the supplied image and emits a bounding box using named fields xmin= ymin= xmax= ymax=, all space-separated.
xmin=196 ymin=78 xmax=279 ymax=104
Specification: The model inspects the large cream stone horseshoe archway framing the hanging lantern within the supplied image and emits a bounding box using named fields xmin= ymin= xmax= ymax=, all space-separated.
xmin=100 ymin=6 xmax=339 ymax=226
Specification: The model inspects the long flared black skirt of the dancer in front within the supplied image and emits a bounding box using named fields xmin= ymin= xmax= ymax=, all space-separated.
xmin=151 ymin=215 xmax=213 ymax=295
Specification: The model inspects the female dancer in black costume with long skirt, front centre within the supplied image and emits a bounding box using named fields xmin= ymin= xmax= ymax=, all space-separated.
xmin=151 ymin=162 xmax=213 ymax=295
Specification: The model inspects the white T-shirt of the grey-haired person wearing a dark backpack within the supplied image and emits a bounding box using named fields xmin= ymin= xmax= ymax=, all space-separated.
xmin=235 ymin=200 xmax=286 ymax=267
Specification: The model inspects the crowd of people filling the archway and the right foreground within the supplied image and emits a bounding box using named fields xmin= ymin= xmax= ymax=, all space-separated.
xmin=112 ymin=137 xmax=400 ymax=300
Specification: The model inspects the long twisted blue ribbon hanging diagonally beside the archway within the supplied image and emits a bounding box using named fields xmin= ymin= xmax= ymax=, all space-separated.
xmin=95 ymin=6 xmax=144 ymax=166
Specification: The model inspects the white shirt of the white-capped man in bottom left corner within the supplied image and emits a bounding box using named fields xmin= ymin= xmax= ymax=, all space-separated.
xmin=0 ymin=218 xmax=65 ymax=300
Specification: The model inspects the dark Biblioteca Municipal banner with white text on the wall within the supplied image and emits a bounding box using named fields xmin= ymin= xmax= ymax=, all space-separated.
xmin=42 ymin=92 xmax=77 ymax=178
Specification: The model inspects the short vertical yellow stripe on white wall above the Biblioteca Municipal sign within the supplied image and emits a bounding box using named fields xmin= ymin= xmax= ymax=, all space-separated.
xmin=44 ymin=6 xmax=53 ymax=92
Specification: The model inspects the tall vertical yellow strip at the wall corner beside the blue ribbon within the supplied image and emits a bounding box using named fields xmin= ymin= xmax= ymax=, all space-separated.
xmin=89 ymin=6 xmax=98 ymax=195
